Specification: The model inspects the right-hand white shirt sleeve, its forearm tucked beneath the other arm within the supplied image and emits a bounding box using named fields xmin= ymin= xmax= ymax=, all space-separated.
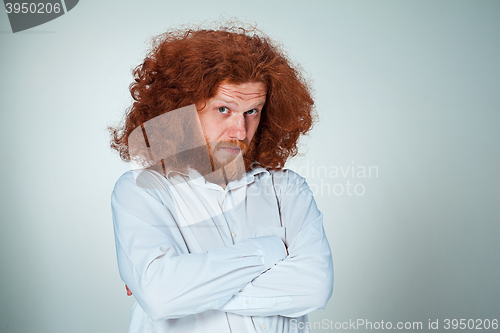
xmin=220 ymin=171 xmax=333 ymax=317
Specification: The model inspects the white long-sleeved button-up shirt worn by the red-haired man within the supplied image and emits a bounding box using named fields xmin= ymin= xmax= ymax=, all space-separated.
xmin=112 ymin=168 xmax=333 ymax=333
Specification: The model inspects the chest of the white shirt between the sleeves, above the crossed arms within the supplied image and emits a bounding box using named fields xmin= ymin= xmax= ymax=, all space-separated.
xmin=165 ymin=176 xmax=286 ymax=253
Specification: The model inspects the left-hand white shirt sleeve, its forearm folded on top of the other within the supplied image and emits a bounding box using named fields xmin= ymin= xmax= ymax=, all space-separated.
xmin=111 ymin=172 xmax=287 ymax=320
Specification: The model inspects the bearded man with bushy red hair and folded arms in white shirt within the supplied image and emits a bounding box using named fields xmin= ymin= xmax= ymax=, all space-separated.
xmin=111 ymin=24 xmax=333 ymax=333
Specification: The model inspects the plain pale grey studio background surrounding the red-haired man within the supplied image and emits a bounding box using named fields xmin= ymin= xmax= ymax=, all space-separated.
xmin=0 ymin=0 xmax=500 ymax=333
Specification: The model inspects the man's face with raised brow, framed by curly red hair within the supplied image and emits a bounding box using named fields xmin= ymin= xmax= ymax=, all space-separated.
xmin=198 ymin=82 xmax=266 ymax=164
